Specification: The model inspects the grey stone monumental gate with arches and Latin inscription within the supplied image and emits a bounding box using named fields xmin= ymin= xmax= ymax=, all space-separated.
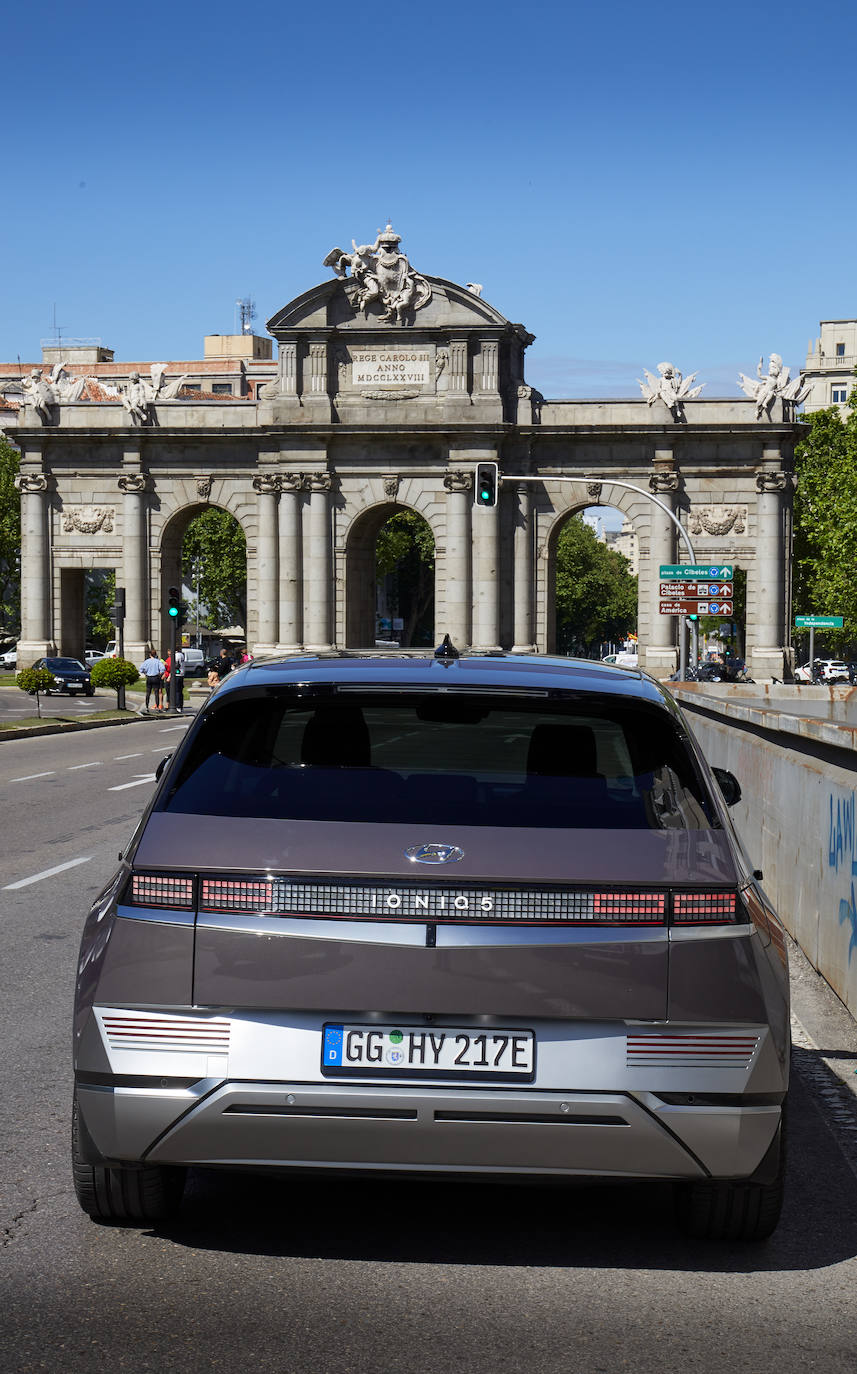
xmin=10 ymin=258 xmax=795 ymax=679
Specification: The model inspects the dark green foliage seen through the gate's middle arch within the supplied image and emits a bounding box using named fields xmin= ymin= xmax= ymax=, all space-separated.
xmin=375 ymin=511 xmax=434 ymax=647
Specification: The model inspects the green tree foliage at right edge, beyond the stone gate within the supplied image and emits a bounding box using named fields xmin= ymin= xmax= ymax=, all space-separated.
xmin=794 ymin=408 xmax=857 ymax=654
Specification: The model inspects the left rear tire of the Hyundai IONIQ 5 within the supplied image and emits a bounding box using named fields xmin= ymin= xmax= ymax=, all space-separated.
xmin=71 ymin=1095 xmax=187 ymax=1226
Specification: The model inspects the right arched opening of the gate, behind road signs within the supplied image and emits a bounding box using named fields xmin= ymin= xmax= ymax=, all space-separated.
xmin=548 ymin=506 xmax=639 ymax=658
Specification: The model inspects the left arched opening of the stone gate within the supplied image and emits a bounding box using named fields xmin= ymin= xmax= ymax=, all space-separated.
xmin=159 ymin=506 xmax=247 ymax=649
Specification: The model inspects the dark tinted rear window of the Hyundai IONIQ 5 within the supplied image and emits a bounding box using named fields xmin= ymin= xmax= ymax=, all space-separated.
xmin=158 ymin=692 xmax=713 ymax=830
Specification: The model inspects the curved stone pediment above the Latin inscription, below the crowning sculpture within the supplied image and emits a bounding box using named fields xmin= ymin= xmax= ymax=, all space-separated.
xmin=268 ymin=276 xmax=521 ymax=342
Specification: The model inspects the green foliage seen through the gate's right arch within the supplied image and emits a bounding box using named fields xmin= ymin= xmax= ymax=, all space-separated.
xmin=556 ymin=515 xmax=637 ymax=655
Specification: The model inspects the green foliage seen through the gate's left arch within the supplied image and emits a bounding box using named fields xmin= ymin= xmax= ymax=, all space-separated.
xmin=181 ymin=507 xmax=247 ymax=627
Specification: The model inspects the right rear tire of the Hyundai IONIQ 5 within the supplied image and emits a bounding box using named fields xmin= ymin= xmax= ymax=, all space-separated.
xmin=674 ymin=1118 xmax=786 ymax=1241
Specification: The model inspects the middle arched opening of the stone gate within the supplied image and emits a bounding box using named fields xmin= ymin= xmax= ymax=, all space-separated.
xmin=345 ymin=503 xmax=435 ymax=649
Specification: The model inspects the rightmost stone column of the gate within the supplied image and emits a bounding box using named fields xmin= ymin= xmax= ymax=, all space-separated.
xmin=746 ymin=448 xmax=790 ymax=682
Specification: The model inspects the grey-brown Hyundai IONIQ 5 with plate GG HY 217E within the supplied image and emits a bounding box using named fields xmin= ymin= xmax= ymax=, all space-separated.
xmin=73 ymin=646 xmax=790 ymax=1239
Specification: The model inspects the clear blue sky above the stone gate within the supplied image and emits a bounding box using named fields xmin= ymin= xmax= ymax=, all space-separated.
xmin=0 ymin=0 xmax=857 ymax=396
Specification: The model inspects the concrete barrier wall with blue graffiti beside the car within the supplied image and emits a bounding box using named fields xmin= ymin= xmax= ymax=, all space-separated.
xmin=676 ymin=687 xmax=857 ymax=1015
